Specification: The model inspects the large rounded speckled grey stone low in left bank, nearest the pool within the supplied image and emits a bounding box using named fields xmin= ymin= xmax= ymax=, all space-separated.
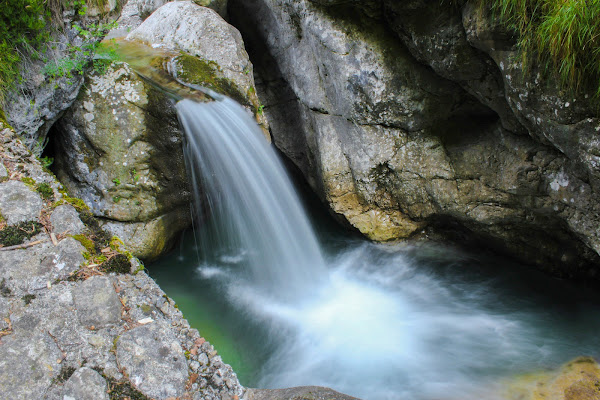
xmin=117 ymin=322 xmax=188 ymax=399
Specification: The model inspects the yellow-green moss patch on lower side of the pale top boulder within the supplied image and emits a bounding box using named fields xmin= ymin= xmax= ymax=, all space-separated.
xmin=175 ymin=53 xmax=252 ymax=106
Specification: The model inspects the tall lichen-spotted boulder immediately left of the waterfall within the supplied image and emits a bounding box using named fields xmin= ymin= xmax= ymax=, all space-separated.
xmin=54 ymin=64 xmax=190 ymax=259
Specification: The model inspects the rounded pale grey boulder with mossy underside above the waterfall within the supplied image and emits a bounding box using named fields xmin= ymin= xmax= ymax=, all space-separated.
xmin=127 ymin=1 xmax=270 ymax=134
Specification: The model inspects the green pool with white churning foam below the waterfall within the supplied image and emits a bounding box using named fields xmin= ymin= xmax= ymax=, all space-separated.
xmin=149 ymin=211 xmax=600 ymax=399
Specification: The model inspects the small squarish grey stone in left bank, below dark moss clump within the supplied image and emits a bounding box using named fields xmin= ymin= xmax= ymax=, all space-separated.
xmin=73 ymin=276 xmax=121 ymax=327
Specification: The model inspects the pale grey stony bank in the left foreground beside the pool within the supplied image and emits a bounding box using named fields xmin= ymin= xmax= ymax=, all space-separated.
xmin=0 ymin=124 xmax=244 ymax=400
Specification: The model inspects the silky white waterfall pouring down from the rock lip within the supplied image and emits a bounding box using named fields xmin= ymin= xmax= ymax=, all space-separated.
xmin=176 ymin=98 xmax=325 ymax=299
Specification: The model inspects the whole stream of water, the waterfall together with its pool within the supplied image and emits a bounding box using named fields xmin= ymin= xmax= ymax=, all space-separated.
xmin=149 ymin=99 xmax=600 ymax=399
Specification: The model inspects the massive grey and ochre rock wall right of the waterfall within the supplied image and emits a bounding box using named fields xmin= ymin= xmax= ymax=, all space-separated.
xmin=229 ymin=0 xmax=600 ymax=277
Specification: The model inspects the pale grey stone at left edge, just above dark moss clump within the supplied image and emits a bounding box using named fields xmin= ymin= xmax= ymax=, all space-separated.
xmin=0 ymin=181 xmax=42 ymax=225
